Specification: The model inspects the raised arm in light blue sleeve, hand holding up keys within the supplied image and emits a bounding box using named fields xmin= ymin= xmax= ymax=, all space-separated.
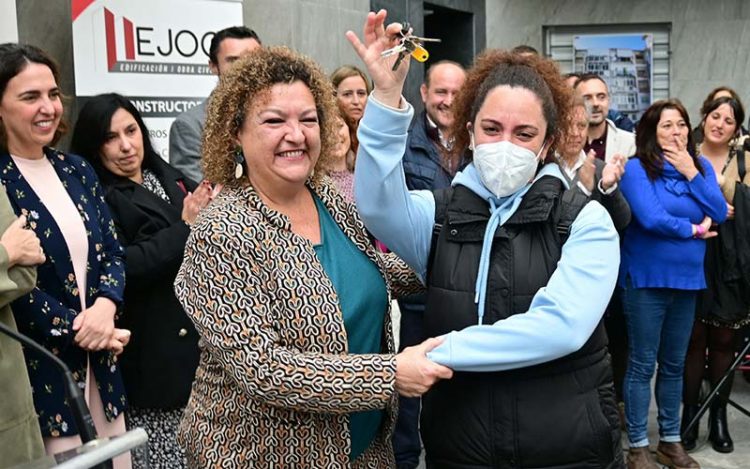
xmin=346 ymin=10 xmax=435 ymax=278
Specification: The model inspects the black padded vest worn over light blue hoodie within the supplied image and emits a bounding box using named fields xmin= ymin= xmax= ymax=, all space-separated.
xmin=421 ymin=177 xmax=622 ymax=469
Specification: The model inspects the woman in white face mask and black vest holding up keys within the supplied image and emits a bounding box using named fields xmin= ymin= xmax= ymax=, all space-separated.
xmin=347 ymin=11 xmax=622 ymax=468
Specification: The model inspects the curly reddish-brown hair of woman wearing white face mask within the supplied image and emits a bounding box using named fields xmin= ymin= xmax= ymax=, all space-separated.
xmin=450 ymin=49 xmax=573 ymax=164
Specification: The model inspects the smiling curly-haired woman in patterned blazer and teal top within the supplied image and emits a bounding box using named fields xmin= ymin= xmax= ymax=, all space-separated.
xmin=175 ymin=44 xmax=452 ymax=468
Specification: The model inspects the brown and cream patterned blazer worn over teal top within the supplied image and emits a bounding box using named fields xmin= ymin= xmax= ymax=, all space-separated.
xmin=175 ymin=178 xmax=422 ymax=468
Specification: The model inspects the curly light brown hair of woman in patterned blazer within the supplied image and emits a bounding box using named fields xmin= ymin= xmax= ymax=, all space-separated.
xmin=202 ymin=47 xmax=338 ymax=187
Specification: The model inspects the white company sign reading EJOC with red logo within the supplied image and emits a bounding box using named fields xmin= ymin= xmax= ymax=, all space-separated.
xmin=71 ymin=0 xmax=242 ymax=159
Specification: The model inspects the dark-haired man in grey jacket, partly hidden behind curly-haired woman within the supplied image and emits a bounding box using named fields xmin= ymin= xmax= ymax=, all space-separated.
xmin=169 ymin=26 xmax=261 ymax=181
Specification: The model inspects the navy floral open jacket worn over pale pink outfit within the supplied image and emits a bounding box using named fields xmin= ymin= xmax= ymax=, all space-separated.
xmin=0 ymin=148 xmax=126 ymax=436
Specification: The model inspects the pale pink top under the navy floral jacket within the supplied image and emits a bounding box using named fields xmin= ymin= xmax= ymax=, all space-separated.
xmin=11 ymin=155 xmax=89 ymax=310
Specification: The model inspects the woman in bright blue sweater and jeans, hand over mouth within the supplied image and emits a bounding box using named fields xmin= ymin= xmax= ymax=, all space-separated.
xmin=619 ymin=100 xmax=727 ymax=469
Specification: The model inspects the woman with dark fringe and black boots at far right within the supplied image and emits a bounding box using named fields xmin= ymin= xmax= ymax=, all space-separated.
xmin=682 ymin=97 xmax=750 ymax=453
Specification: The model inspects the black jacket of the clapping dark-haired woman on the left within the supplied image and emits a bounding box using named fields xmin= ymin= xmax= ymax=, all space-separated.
xmin=98 ymin=157 xmax=199 ymax=409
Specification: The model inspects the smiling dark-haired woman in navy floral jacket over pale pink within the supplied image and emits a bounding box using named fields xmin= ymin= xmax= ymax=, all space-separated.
xmin=0 ymin=44 xmax=130 ymax=468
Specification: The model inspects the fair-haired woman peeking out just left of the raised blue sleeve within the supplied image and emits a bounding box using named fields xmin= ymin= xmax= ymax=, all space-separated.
xmin=331 ymin=65 xmax=372 ymax=154
